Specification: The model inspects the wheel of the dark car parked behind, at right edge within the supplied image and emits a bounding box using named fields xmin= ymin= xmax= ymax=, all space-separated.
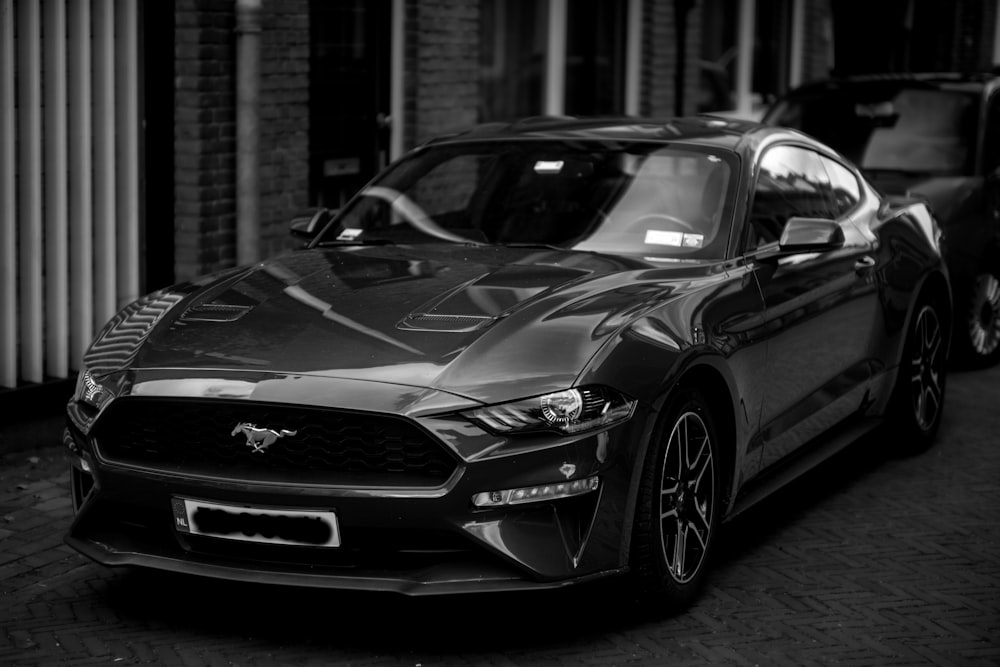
xmin=955 ymin=262 xmax=1000 ymax=368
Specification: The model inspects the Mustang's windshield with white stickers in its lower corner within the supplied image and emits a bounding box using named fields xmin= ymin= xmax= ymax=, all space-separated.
xmin=318 ymin=140 xmax=737 ymax=259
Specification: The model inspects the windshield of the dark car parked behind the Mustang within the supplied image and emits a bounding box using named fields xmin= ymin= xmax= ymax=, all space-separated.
xmin=767 ymin=82 xmax=978 ymax=176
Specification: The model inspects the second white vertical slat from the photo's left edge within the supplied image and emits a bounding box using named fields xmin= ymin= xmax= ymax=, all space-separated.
xmin=17 ymin=0 xmax=44 ymax=382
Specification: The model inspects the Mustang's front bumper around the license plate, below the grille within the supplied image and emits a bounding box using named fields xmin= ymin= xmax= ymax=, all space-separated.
xmin=65 ymin=404 xmax=642 ymax=595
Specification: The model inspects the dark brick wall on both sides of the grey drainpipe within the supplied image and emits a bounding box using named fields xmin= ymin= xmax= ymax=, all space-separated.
xmin=174 ymin=0 xmax=309 ymax=280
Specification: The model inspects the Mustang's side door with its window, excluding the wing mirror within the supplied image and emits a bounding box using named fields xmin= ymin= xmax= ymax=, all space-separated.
xmin=745 ymin=145 xmax=878 ymax=471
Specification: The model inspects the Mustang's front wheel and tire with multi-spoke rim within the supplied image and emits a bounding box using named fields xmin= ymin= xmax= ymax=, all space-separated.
xmin=630 ymin=390 xmax=721 ymax=613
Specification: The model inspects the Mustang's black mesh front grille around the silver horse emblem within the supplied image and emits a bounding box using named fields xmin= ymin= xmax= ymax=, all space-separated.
xmin=94 ymin=398 xmax=457 ymax=487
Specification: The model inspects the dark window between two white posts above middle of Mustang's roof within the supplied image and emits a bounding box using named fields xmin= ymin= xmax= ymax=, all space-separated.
xmin=565 ymin=0 xmax=628 ymax=116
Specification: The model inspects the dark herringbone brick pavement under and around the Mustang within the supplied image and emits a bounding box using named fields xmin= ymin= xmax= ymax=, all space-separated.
xmin=0 ymin=368 xmax=1000 ymax=666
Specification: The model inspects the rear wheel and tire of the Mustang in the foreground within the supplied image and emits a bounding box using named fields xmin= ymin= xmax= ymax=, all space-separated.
xmin=891 ymin=299 xmax=948 ymax=454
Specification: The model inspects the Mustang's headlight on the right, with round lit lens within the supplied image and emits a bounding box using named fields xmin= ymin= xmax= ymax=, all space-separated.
xmin=462 ymin=386 xmax=636 ymax=434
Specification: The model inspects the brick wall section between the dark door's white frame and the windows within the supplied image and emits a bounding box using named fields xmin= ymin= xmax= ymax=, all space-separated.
xmin=404 ymin=0 xmax=479 ymax=148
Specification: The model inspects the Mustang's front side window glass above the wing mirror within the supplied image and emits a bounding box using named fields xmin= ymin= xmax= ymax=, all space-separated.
xmin=747 ymin=146 xmax=837 ymax=250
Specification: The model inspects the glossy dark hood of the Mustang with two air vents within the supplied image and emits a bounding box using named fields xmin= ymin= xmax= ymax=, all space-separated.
xmin=88 ymin=245 xmax=712 ymax=402
